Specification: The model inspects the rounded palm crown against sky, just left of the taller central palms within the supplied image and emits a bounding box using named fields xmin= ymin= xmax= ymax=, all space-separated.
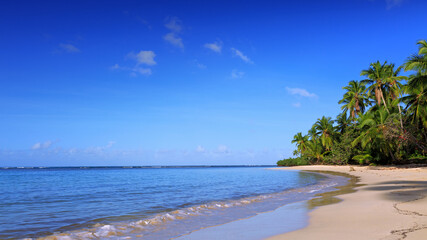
xmin=338 ymin=80 xmax=369 ymax=120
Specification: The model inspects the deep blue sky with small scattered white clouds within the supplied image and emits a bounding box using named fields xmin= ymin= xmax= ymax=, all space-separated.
xmin=0 ymin=0 xmax=427 ymax=166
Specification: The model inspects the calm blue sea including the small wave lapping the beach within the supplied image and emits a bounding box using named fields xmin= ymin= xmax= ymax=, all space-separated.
xmin=0 ymin=167 xmax=344 ymax=240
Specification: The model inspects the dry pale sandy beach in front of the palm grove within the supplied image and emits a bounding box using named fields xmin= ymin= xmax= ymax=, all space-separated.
xmin=268 ymin=166 xmax=427 ymax=240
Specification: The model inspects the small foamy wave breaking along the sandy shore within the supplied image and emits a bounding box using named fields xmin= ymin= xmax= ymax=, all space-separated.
xmin=27 ymin=173 xmax=348 ymax=240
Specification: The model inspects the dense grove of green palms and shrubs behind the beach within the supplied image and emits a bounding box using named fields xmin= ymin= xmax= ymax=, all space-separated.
xmin=277 ymin=40 xmax=427 ymax=166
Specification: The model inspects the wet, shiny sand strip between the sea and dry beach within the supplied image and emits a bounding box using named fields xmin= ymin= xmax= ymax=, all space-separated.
xmin=174 ymin=168 xmax=352 ymax=240
